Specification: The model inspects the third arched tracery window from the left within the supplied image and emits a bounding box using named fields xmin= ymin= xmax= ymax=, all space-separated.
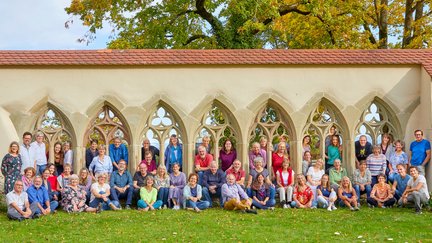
xmin=143 ymin=104 xmax=184 ymax=161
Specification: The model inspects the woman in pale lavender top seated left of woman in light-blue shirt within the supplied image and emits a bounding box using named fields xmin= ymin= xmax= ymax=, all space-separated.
xmin=168 ymin=163 xmax=186 ymax=210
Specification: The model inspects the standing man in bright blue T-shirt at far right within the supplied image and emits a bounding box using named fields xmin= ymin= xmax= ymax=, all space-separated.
xmin=408 ymin=130 xmax=431 ymax=175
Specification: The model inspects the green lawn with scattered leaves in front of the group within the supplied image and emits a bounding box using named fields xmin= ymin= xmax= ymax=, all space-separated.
xmin=0 ymin=203 xmax=432 ymax=242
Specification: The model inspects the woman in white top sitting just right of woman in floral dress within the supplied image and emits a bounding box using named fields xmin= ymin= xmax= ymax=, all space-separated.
xmin=89 ymin=173 xmax=121 ymax=211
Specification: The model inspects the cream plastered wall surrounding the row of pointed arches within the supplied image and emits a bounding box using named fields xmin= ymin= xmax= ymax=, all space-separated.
xmin=0 ymin=65 xmax=432 ymax=186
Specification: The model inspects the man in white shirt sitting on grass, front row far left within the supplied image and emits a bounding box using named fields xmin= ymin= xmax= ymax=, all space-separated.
xmin=6 ymin=179 xmax=38 ymax=221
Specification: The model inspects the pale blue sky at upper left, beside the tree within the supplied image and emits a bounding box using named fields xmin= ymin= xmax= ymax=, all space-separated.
xmin=0 ymin=0 xmax=110 ymax=50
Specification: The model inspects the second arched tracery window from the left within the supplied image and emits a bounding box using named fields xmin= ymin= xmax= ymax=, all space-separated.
xmin=84 ymin=104 xmax=130 ymax=151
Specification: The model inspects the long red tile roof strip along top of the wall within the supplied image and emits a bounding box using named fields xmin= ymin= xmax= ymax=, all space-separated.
xmin=0 ymin=49 xmax=432 ymax=75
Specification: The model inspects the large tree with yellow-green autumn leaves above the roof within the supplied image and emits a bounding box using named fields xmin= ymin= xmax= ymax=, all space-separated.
xmin=66 ymin=0 xmax=432 ymax=49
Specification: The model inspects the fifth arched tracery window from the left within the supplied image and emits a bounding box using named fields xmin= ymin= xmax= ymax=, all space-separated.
xmin=249 ymin=103 xmax=292 ymax=158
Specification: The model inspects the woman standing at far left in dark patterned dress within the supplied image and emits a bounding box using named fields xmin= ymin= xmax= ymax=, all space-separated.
xmin=1 ymin=142 xmax=22 ymax=194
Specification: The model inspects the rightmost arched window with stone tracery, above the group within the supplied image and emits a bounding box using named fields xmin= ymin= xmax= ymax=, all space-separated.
xmin=355 ymin=100 xmax=399 ymax=144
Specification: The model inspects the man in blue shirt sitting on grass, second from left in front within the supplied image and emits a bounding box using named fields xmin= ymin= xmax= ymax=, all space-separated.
xmin=27 ymin=176 xmax=58 ymax=215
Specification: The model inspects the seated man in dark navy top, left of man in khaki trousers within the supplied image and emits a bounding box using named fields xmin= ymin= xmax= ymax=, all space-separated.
xmin=202 ymin=161 xmax=226 ymax=207
